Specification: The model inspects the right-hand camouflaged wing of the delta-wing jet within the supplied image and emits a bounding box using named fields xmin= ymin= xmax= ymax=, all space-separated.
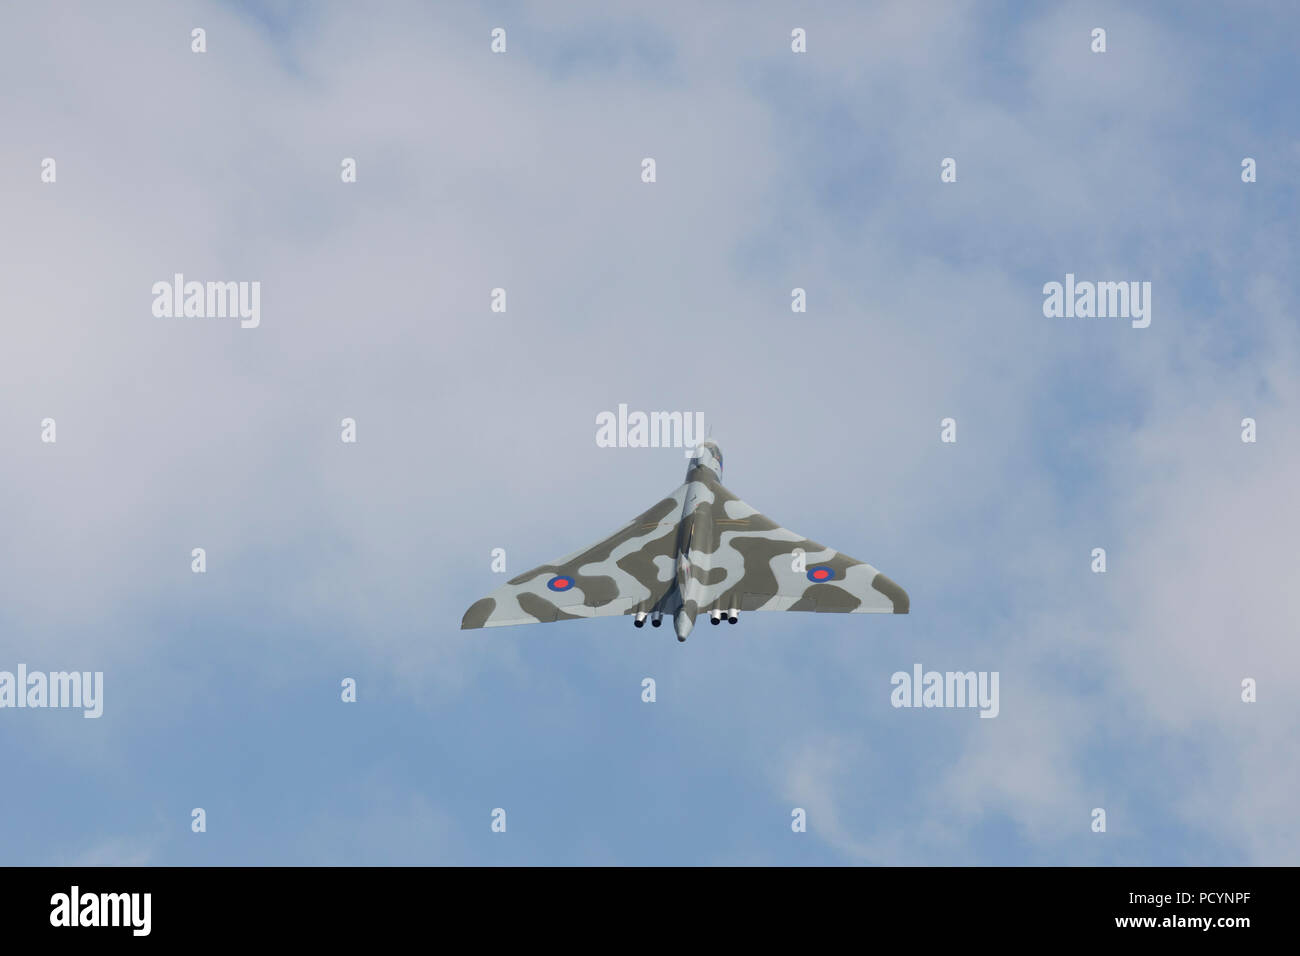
xmin=693 ymin=485 xmax=909 ymax=614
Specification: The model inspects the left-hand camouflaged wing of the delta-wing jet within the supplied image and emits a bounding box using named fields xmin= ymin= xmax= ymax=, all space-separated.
xmin=460 ymin=485 xmax=686 ymax=630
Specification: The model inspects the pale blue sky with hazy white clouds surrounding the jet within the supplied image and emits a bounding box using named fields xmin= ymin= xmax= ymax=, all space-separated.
xmin=0 ymin=0 xmax=1300 ymax=865
